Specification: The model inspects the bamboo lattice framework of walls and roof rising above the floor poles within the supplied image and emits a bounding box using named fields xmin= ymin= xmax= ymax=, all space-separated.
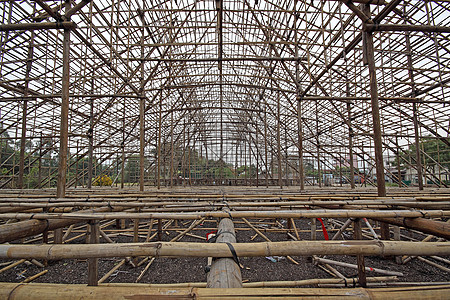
xmin=0 ymin=0 xmax=450 ymax=190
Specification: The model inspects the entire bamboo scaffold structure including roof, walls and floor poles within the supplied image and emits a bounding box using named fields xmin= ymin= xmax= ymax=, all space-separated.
xmin=0 ymin=0 xmax=450 ymax=297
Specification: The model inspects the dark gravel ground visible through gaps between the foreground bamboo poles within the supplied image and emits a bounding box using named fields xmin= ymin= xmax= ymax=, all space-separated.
xmin=0 ymin=220 xmax=449 ymax=284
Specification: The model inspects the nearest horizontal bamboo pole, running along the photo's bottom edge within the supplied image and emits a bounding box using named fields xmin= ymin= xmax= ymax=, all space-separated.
xmin=0 ymin=283 xmax=450 ymax=300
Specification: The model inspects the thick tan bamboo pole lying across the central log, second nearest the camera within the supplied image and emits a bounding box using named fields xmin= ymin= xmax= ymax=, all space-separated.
xmin=0 ymin=240 xmax=450 ymax=260
